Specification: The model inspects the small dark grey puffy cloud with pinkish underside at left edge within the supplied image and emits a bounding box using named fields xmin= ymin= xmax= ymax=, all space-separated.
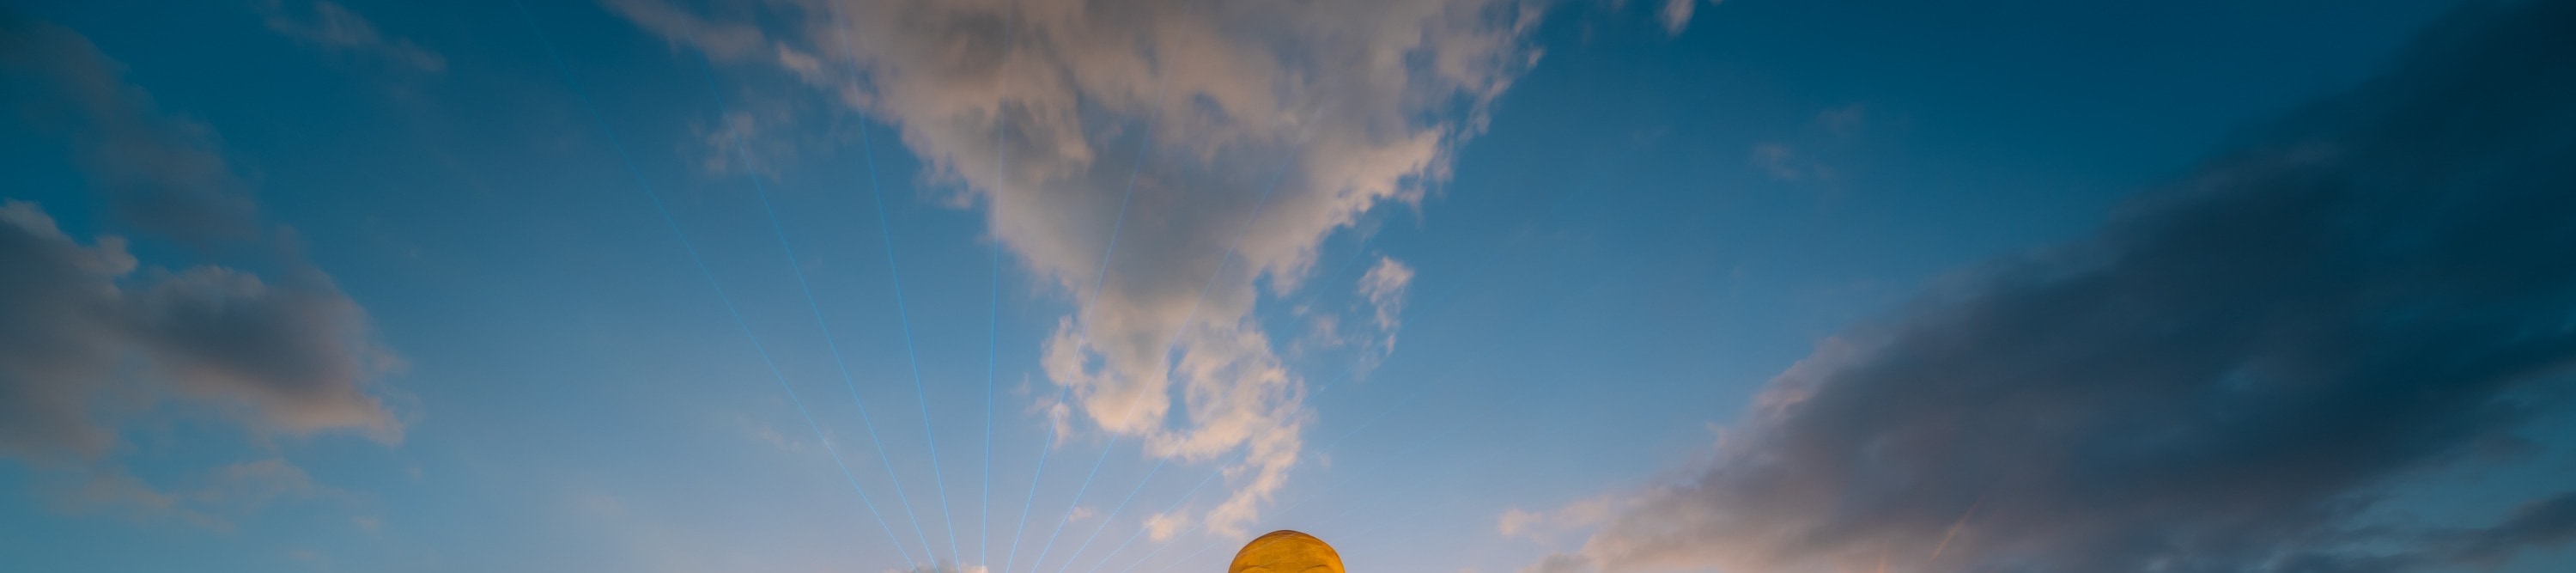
xmin=0 ymin=201 xmax=402 ymax=457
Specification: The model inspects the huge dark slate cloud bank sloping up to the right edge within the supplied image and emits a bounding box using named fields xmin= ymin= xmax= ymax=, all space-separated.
xmin=1530 ymin=3 xmax=2576 ymax=573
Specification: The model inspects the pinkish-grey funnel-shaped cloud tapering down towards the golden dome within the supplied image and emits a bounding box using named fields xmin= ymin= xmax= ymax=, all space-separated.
xmin=608 ymin=0 xmax=1540 ymax=534
